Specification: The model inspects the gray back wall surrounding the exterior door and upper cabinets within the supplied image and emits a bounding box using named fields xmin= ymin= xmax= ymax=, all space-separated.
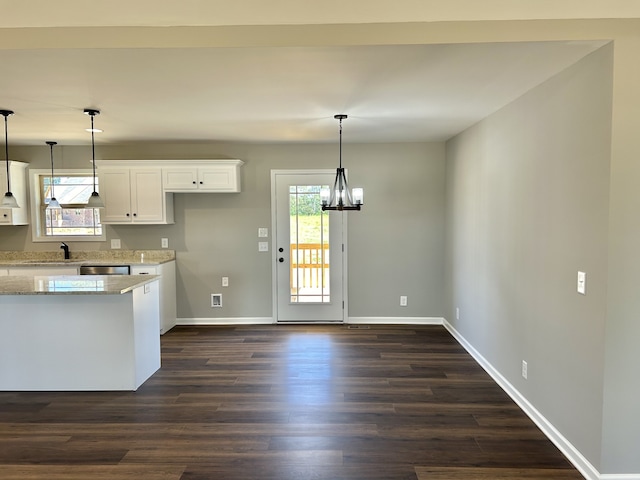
xmin=0 ymin=143 xmax=444 ymax=318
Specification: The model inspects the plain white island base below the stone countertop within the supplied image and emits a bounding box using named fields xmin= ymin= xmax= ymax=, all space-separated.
xmin=0 ymin=281 xmax=160 ymax=391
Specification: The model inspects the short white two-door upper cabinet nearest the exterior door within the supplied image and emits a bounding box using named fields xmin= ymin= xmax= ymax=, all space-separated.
xmin=162 ymin=160 xmax=244 ymax=193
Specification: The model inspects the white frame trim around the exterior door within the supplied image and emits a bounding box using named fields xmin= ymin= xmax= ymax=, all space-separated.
xmin=271 ymin=168 xmax=349 ymax=324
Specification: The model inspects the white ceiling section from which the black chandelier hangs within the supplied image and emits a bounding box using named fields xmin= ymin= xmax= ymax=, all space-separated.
xmin=0 ymin=41 xmax=603 ymax=145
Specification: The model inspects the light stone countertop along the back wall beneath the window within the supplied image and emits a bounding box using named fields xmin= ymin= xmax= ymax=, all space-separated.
xmin=0 ymin=250 xmax=176 ymax=267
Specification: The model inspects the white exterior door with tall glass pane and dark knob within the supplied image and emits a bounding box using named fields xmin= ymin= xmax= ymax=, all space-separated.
xmin=271 ymin=170 xmax=346 ymax=322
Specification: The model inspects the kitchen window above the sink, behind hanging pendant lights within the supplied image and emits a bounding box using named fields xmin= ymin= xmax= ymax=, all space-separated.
xmin=31 ymin=170 xmax=105 ymax=242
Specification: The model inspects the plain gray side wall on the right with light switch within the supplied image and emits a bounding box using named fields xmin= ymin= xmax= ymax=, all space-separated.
xmin=446 ymin=45 xmax=613 ymax=468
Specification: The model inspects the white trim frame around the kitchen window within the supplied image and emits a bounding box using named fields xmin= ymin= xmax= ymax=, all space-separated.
xmin=29 ymin=169 xmax=107 ymax=243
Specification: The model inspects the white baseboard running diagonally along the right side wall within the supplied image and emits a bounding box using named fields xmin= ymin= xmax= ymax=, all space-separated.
xmin=444 ymin=320 xmax=616 ymax=480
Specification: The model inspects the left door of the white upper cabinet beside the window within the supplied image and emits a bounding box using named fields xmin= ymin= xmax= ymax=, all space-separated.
xmin=100 ymin=168 xmax=132 ymax=223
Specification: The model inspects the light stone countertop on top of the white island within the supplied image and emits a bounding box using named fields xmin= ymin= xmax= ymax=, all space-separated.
xmin=0 ymin=275 xmax=160 ymax=295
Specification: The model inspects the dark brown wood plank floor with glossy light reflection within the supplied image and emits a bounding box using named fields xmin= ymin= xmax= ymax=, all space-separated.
xmin=0 ymin=325 xmax=582 ymax=480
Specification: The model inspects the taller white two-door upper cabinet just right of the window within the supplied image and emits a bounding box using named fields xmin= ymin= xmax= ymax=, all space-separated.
xmin=97 ymin=161 xmax=173 ymax=225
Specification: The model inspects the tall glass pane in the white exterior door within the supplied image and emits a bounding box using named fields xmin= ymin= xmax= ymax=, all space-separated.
xmin=289 ymin=185 xmax=331 ymax=304
